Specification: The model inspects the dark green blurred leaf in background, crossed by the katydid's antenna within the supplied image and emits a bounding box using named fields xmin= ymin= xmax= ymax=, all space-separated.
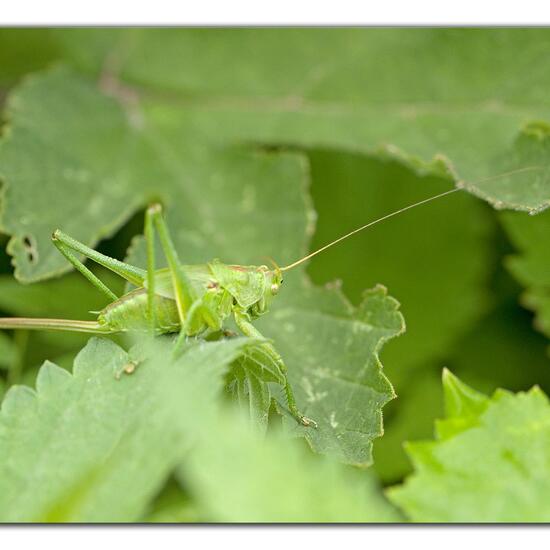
xmin=309 ymin=151 xmax=493 ymax=384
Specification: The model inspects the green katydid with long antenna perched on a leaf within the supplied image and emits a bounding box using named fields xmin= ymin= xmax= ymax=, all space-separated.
xmin=0 ymin=167 xmax=538 ymax=427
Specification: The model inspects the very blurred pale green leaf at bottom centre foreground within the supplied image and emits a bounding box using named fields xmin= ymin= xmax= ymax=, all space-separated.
xmin=179 ymin=414 xmax=401 ymax=523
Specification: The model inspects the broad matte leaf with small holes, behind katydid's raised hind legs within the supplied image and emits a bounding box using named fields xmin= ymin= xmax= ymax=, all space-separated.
xmin=0 ymin=69 xmax=307 ymax=281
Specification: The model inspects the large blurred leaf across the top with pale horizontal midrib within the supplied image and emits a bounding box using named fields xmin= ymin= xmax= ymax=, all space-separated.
xmin=52 ymin=28 xmax=550 ymax=211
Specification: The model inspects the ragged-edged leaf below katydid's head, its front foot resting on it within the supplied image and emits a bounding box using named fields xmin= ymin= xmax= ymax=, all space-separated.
xmin=257 ymin=284 xmax=404 ymax=465
